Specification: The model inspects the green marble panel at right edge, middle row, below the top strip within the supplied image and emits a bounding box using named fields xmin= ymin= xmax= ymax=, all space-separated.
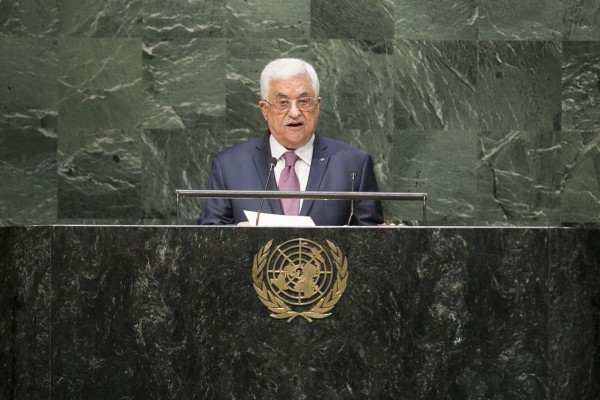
xmin=561 ymin=42 xmax=600 ymax=132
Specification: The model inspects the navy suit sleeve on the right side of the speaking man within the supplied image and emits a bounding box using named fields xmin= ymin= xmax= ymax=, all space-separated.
xmin=350 ymin=154 xmax=384 ymax=225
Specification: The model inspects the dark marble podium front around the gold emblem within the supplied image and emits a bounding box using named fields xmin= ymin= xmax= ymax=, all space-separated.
xmin=0 ymin=226 xmax=600 ymax=400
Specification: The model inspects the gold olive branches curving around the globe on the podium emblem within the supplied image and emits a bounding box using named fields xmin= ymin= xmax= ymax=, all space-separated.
xmin=252 ymin=239 xmax=348 ymax=322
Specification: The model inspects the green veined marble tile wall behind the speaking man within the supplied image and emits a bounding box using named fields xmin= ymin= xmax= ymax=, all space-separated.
xmin=0 ymin=0 xmax=600 ymax=225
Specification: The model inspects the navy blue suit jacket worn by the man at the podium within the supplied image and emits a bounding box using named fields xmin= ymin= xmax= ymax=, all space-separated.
xmin=198 ymin=132 xmax=383 ymax=226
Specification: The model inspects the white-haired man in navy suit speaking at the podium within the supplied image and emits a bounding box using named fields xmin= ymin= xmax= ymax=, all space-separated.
xmin=199 ymin=58 xmax=383 ymax=226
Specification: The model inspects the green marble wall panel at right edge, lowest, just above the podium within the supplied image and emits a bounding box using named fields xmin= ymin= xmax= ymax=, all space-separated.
xmin=560 ymin=132 xmax=600 ymax=223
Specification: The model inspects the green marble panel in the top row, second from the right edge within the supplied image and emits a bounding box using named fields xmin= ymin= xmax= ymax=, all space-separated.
xmin=477 ymin=0 xmax=563 ymax=40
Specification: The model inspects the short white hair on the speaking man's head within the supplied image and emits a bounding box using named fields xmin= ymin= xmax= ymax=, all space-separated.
xmin=260 ymin=58 xmax=319 ymax=99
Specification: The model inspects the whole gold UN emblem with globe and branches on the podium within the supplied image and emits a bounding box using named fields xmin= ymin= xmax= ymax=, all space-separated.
xmin=252 ymin=238 xmax=348 ymax=322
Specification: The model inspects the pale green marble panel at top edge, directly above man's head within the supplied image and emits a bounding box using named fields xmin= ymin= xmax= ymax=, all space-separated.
xmin=224 ymin=0 xmax=311 ymax=38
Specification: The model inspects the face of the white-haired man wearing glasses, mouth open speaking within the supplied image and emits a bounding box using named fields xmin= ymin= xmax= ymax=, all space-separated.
xmin=258 ymin=76 xmax=321 ymax=150
